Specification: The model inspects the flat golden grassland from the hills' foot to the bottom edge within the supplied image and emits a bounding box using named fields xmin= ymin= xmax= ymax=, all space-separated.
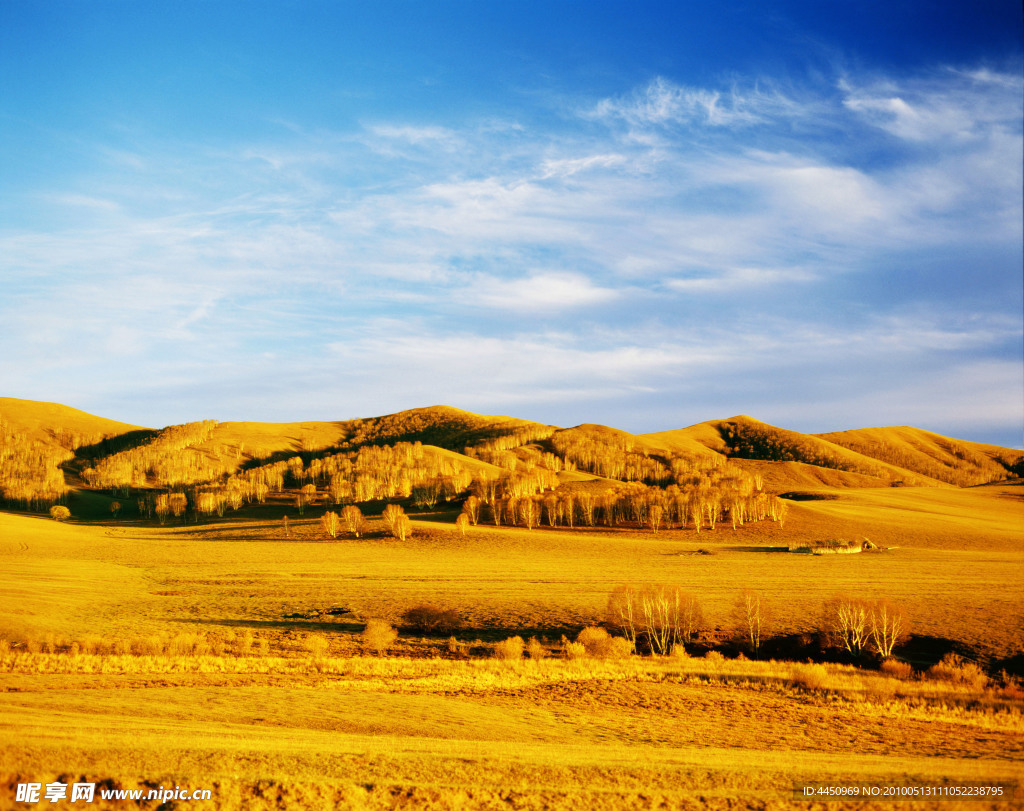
xmin=0 ymin=485 xmax=1024 ymax=809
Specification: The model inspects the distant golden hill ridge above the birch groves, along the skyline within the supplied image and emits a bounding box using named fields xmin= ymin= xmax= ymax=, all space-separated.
xmin=0 ymin=397 xmax=1024 ymax=488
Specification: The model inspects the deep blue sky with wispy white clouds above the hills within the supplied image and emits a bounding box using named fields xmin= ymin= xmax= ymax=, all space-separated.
xmin=0 ymin=0 xmax=1024 ymax=446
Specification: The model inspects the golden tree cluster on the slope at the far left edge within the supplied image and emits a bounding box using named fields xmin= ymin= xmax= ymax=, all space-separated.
xmin=0 ymin=418 xmax=74 ymax=510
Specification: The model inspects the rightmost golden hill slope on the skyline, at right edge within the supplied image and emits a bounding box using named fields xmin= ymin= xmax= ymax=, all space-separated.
xmin=817 ymin=425 xmax=1024 ymax=486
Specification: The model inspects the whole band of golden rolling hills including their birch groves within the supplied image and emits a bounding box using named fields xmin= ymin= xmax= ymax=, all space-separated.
xmin=0 ymin=397 xmax=1024 ymax=516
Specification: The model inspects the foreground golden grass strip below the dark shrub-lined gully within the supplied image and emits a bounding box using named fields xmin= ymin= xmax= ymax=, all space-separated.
xmin=0 ymin=651 xmax=1024 ymax=808
